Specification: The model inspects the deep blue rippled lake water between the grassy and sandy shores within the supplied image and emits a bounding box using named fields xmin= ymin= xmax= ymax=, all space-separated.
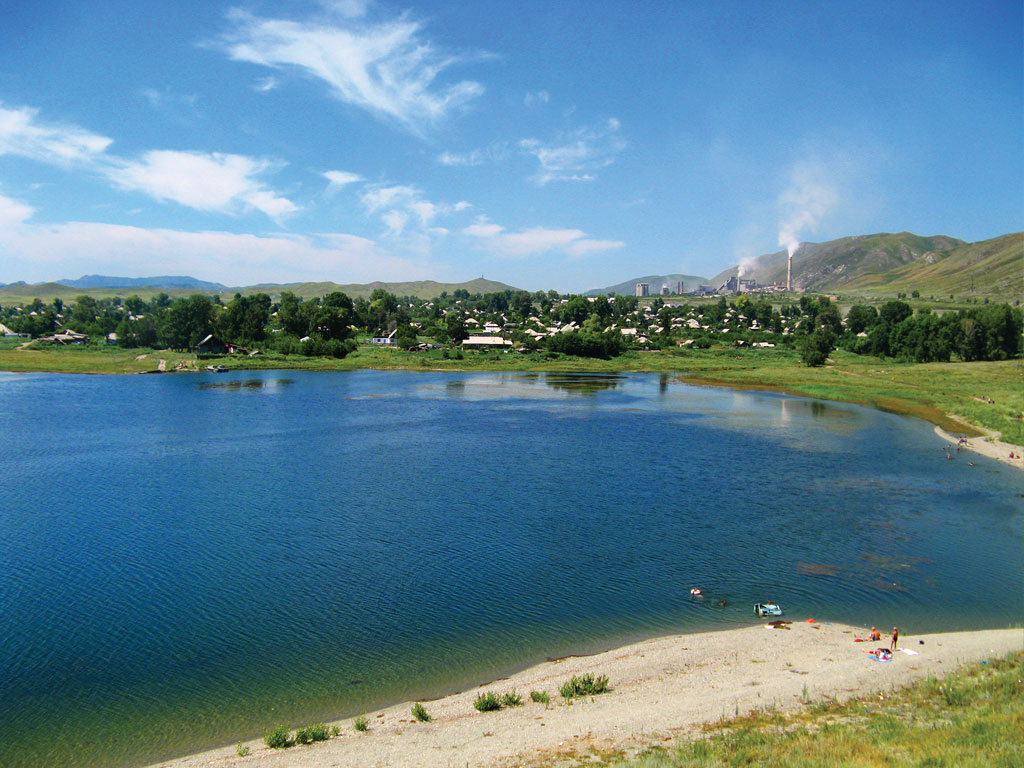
xmin=0 ymin=371 xmax=1024 ymax=768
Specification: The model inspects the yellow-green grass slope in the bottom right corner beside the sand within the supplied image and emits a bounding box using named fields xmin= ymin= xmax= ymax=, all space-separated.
xmin=598 ymin=651 xmax=1024 ymax=768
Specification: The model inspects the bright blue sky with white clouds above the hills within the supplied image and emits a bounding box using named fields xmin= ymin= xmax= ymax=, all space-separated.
xmin=0 ymin=0 xmax=1024 ymax=291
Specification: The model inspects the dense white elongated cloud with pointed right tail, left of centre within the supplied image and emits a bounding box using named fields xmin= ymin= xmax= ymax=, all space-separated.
xmin=108 ymin=150 xmax=298 ymax=219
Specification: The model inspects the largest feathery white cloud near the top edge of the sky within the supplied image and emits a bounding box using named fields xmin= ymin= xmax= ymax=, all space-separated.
xmin=220 ymin=8 xmax=483 ymax=131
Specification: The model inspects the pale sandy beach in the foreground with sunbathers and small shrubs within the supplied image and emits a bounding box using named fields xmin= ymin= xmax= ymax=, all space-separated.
xmin=148 ymin=621 xmax=1024 ymax=768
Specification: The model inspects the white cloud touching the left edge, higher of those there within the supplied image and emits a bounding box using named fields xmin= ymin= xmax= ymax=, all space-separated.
xmin=0 ymin=103 xmax=113 ymax=165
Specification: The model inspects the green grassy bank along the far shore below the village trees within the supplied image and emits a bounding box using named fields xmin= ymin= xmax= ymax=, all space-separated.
xmin=0 ymin=340 xmax=1024 ymax=445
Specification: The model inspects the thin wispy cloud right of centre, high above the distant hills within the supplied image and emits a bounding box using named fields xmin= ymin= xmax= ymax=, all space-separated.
xmin=519 ymin=118 xmax=626 ymax=186
